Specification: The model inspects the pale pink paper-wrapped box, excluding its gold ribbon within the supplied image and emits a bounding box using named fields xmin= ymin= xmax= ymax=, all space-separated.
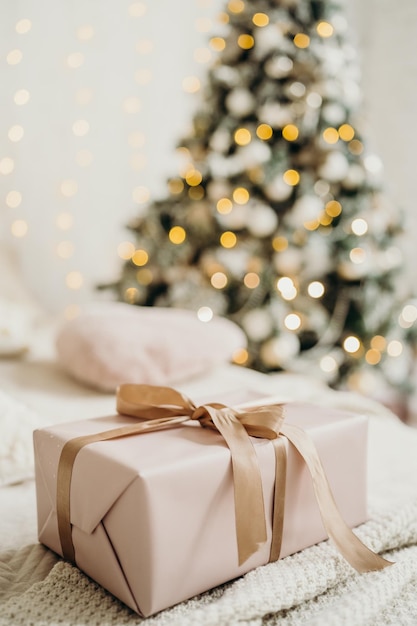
xmin=34 ymin=394 xmax=367 ymax=617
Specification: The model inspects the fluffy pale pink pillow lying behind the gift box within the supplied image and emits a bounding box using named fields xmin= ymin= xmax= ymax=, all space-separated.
xmin=56 ymin=302 xmax=246 ymax=391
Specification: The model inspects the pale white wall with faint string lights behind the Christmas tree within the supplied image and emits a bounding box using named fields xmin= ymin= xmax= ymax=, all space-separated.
xmin=0 ymin=0 xmax=417 ymax=317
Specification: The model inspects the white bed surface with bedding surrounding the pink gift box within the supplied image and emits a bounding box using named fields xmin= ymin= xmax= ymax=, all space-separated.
xmin=0 ymin=324 xmax=417 ymax=626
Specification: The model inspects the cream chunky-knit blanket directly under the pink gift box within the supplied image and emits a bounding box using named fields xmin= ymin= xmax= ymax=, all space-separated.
xmin=0 ymin=498 xmax=417 ymax=626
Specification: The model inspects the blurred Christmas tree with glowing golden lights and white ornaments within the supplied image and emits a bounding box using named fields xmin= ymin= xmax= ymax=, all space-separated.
xmin=111 ymin=0 xmax=417 ymax=392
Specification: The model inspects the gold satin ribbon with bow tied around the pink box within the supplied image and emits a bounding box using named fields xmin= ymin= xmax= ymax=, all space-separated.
xmin=57 ymin=384 xmax=391 ymax=572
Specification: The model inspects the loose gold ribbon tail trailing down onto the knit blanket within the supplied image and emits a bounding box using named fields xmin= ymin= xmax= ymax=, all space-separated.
xmin=281 ymin=424 xmax=393 ymax=573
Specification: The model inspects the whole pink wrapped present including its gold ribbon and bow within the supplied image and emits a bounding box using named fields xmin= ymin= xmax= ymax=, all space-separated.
xmin=34 ymin=385 xmax=389 ymax=616
